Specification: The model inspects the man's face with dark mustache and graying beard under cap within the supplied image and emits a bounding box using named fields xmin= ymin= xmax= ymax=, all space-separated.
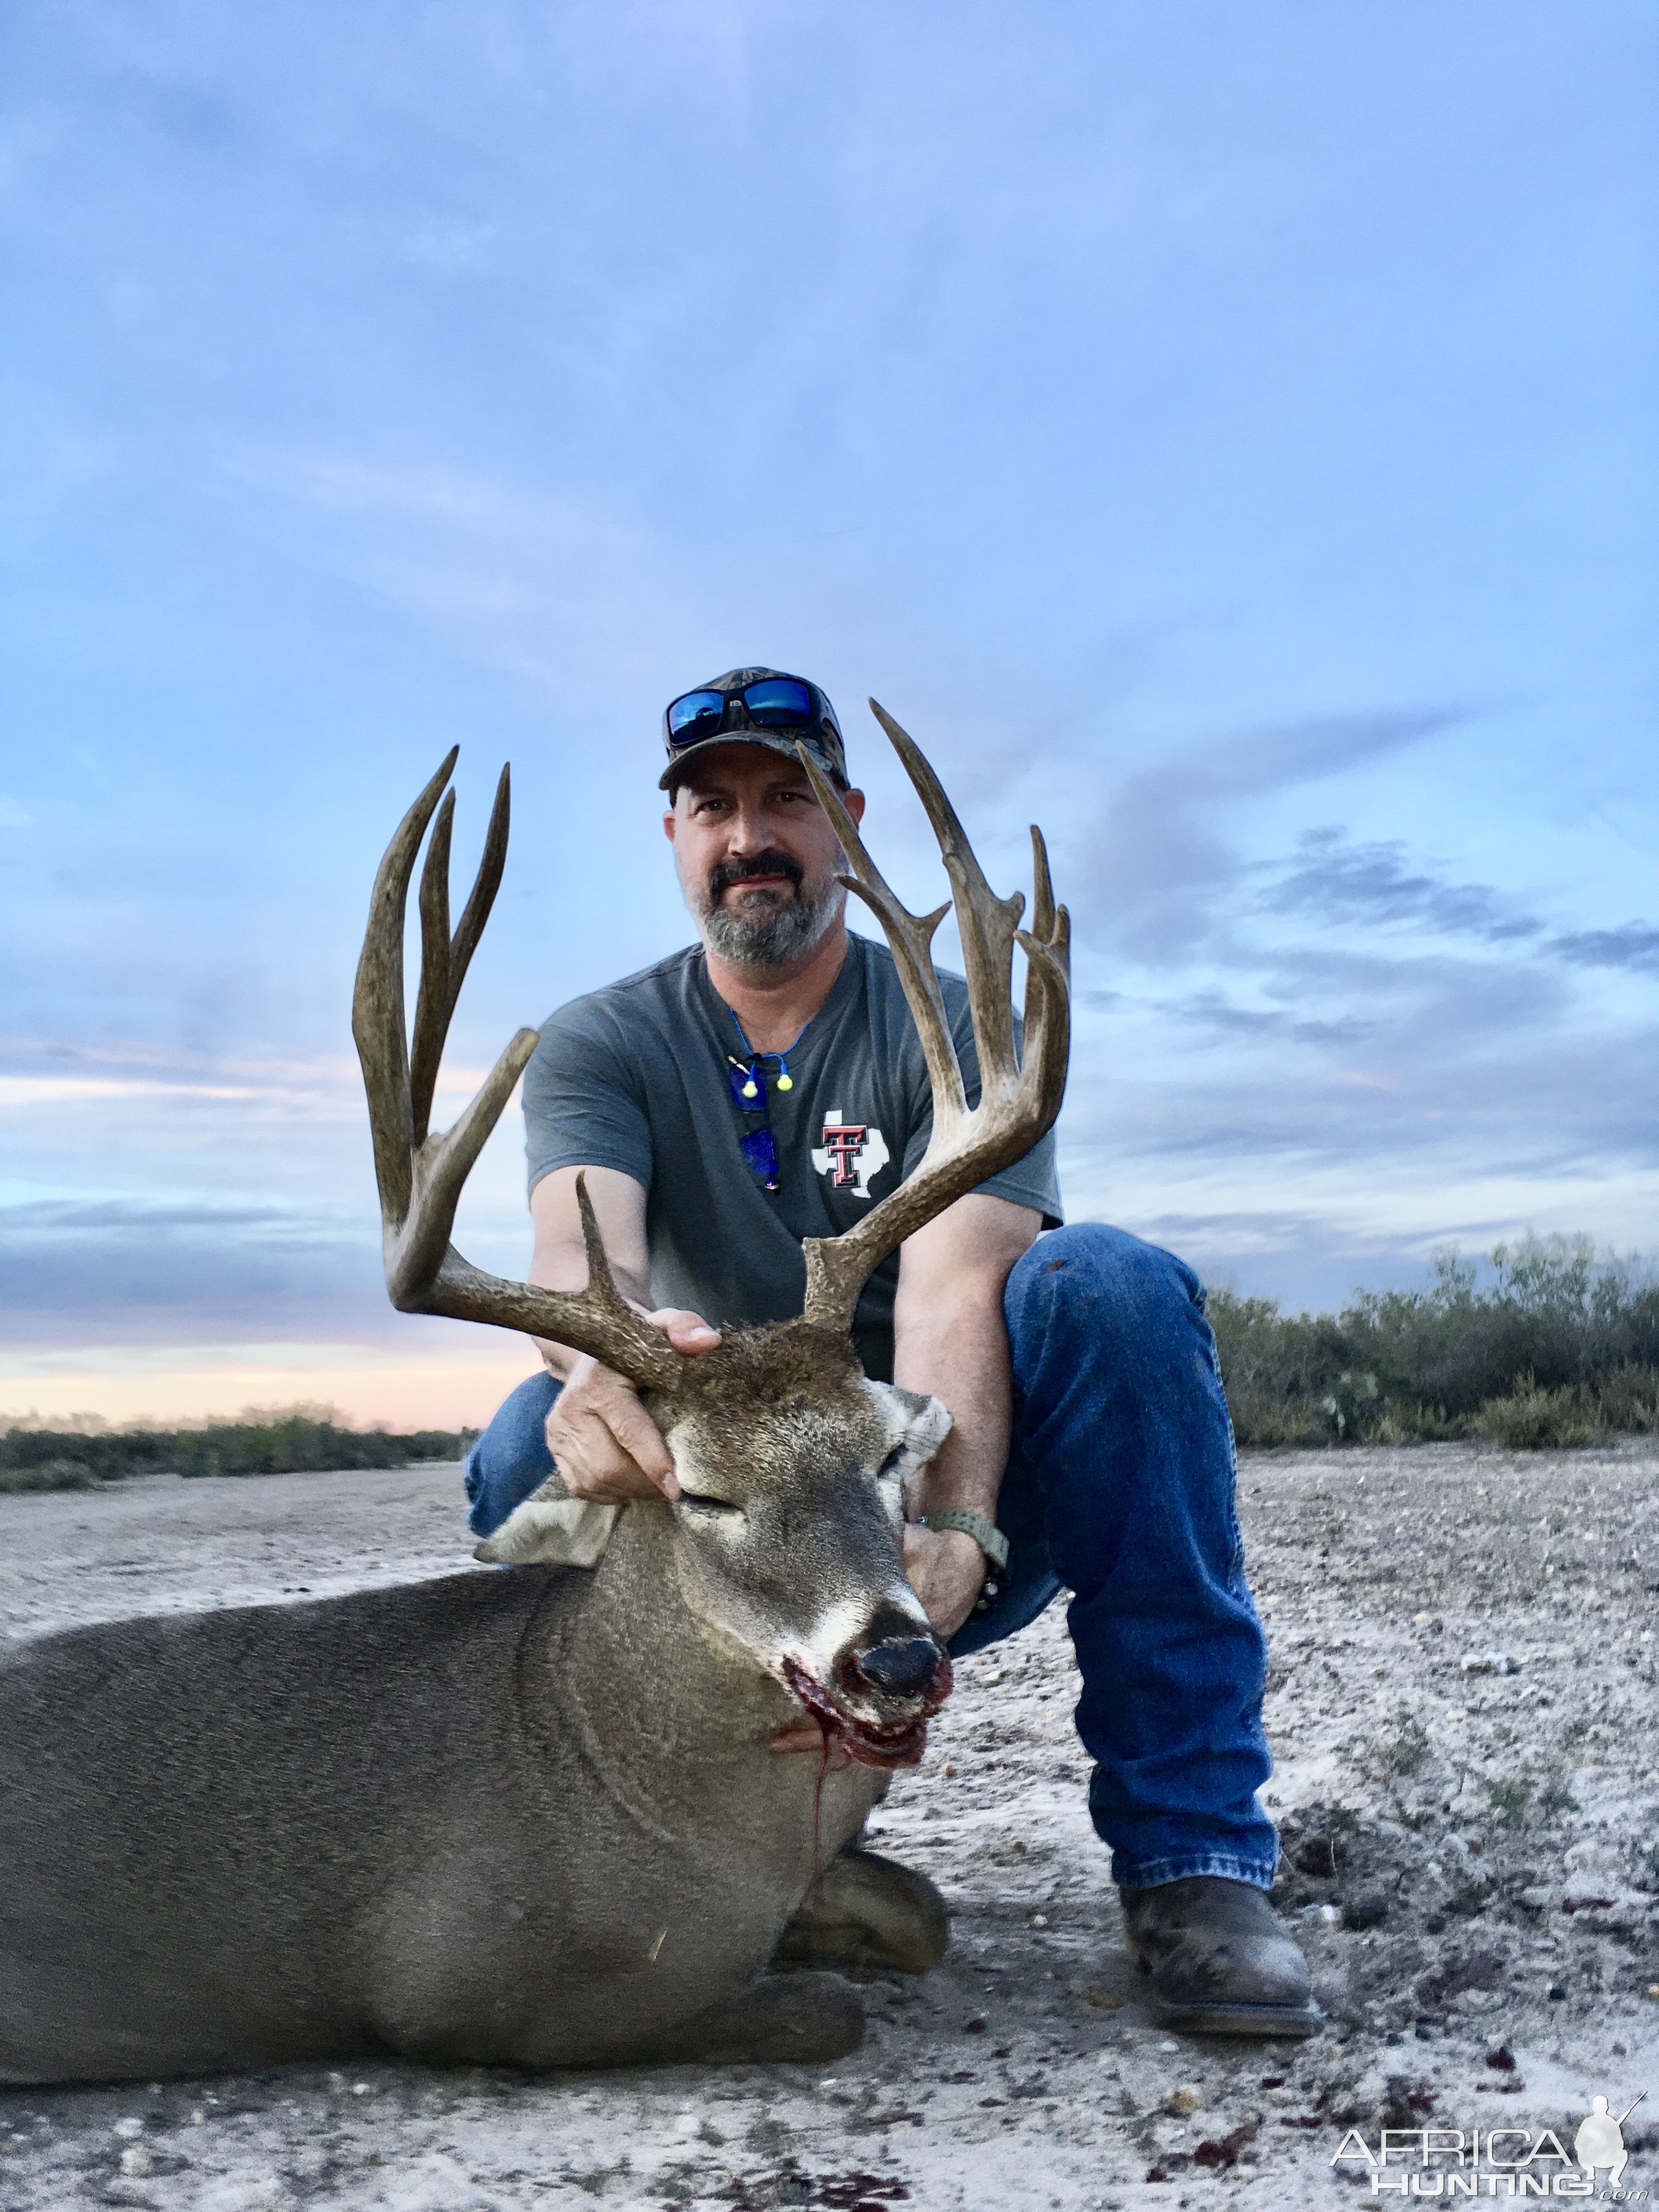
xmin=664 ymin=743 xmax=865 ymax=969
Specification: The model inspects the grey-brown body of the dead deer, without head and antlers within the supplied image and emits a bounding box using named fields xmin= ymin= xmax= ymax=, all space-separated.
xmin=0 ymin=1509 xmax=881 ymax=2081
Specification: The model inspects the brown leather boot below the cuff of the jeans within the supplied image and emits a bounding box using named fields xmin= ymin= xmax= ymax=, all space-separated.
xmin=1119 ymin=1874 xmax=1325 ymax=2035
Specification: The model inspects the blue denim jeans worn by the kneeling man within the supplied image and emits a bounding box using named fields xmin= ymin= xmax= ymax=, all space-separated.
xmin=467 ymin=1221 xmax=1278 ymax=1889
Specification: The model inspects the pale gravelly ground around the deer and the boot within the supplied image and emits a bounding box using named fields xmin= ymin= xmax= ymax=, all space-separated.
xmin=0 ymin=1442 xmax=1659 ymax=2212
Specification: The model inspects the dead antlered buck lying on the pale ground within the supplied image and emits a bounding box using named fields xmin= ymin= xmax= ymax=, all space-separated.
xmin=0 ymin=716 xmax=1068 ymax=2081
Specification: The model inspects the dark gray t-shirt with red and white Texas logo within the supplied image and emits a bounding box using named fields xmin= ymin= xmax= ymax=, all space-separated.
xmin=524 ymin=936 xmax=1062 ymax=1380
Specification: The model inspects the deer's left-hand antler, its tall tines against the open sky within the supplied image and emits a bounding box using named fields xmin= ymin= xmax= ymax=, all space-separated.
xmin=352 ymin=746 xmax=686 ymax=1389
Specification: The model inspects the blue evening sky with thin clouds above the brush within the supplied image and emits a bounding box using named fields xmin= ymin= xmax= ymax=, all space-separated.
xmin=0 ymin=0 xmax=1659 ymax=1427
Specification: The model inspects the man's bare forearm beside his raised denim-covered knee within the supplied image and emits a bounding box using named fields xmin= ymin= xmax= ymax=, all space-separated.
xmin=894 ymin=1283 xmax=1013 ymax=1520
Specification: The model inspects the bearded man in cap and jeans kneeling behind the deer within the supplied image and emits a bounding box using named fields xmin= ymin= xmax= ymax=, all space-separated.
xmin=467 ymin=668 xmax=1318 ymax=2035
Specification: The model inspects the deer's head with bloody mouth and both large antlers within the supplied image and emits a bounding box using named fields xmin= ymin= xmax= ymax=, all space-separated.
xmin=352 ymin=701 xmax=1068 ymax=1765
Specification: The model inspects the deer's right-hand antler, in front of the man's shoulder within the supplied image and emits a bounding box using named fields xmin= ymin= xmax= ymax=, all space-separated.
xmin=797 ymin=699 xmax=1070 ymax=1331
